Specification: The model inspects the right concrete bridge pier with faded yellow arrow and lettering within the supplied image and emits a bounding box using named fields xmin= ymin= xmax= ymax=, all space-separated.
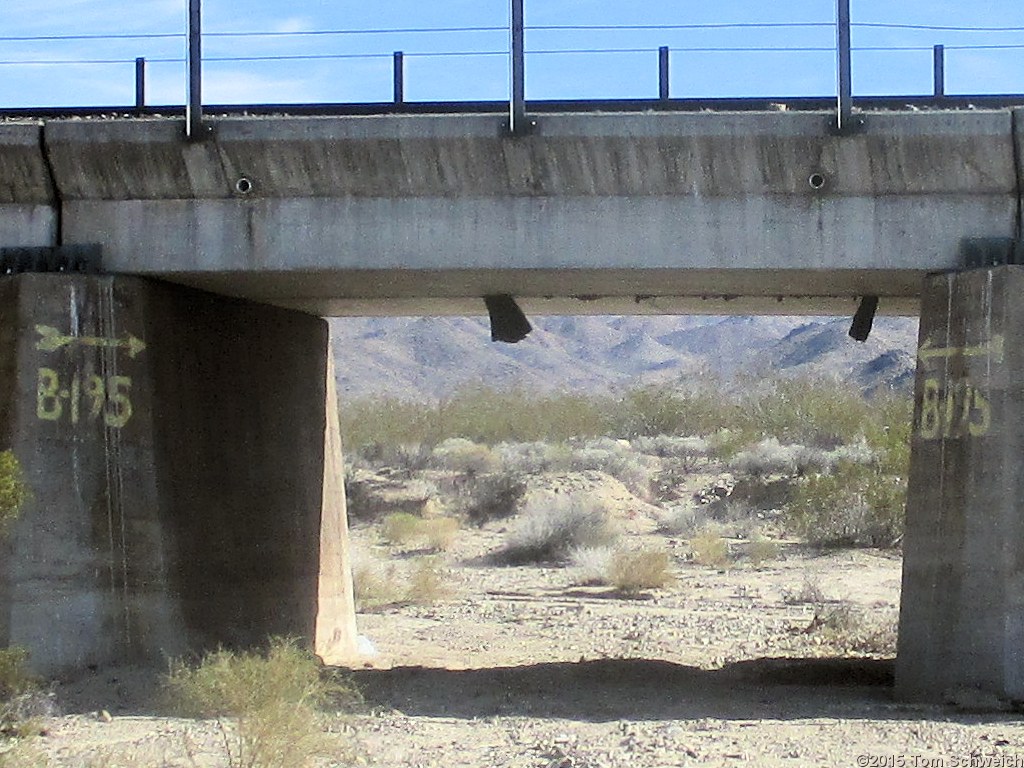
xmin=896 ymin=266 xmax=1024 ymax=701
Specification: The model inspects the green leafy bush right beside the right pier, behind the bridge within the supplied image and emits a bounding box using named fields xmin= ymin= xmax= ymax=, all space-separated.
xmin=784 ymin=462 xmax=906 ymax=547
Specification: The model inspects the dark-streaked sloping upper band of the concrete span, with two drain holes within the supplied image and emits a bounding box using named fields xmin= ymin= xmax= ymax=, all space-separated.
xmin=39 ymin=111 xmax=1017 ymax=200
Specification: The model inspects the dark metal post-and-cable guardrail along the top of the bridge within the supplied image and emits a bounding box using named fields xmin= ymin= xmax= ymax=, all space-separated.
xmin=0 ymin=0 xmax=1024 ymax=125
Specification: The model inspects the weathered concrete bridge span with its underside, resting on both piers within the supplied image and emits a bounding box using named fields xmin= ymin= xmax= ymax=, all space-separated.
xmin=0 ymin=110 xmax=1020 ymax=314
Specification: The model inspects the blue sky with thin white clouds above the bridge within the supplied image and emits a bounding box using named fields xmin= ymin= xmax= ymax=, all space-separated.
xmin=0 ymin=0 xmax=1024 ymax=106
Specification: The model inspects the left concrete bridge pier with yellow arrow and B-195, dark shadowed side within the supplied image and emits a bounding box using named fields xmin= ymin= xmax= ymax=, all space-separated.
xmin=0 ymin=274 xmax=354 ymax=674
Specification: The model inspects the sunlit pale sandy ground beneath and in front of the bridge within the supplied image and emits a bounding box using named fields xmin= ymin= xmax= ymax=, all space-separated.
xmin=14 ymin=524 xmax=1024 ymax=768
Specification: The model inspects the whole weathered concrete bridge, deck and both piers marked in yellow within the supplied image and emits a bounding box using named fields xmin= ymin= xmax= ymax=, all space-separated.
xmin=0 ymin=108 xmax=1024 ymax=699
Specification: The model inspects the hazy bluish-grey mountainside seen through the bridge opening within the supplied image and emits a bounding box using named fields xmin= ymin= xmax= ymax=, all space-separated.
xmin=331 ymin=315 xmax=918 ymax=399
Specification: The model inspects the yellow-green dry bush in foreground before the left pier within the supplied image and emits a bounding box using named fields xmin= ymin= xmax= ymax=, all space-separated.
xmin=164 ymin=638 xmax=358 ymax=768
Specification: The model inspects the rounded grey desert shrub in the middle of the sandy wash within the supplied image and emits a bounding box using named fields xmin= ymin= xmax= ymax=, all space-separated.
xmin=495 ymin=493 xmax=615 ymax=564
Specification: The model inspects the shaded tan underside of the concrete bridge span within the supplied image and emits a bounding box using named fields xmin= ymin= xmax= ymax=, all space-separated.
xmin=164 ymin=268 xmax=925 ymax=316
